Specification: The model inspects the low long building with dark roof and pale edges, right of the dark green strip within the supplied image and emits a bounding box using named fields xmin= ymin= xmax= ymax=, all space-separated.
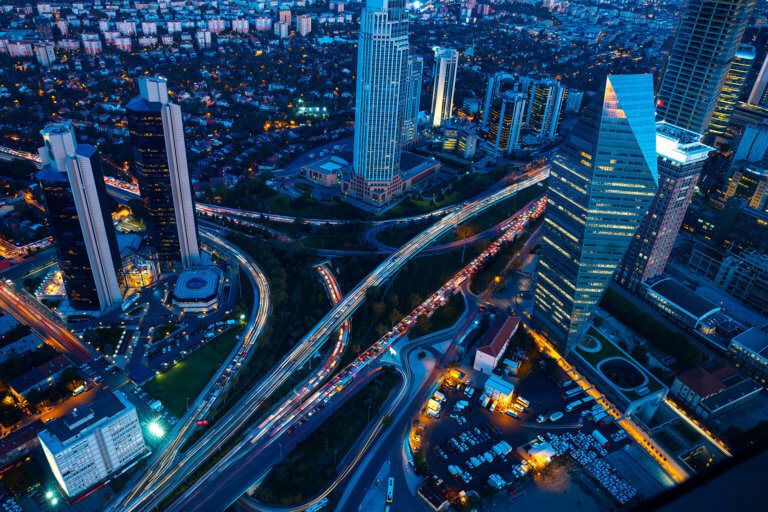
xmin=645 ymin=278 xmax=721 ymax=332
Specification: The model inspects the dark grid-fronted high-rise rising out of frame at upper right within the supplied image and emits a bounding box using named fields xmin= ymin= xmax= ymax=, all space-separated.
xmin=657 ymin=0 xmax=756 ymax=133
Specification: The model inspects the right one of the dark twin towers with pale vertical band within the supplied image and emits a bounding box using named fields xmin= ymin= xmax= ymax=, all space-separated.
xmin=126 ymin=77 xmax=200 ymax=268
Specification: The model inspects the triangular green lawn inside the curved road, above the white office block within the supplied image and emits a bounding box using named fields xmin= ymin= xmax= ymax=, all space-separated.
xmin=144 ymin=329 xmax=240 ymax=416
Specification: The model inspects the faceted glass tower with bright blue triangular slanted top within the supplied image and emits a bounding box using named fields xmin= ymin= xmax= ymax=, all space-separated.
xmin=534 ymin=75 xmax=658 ymax=351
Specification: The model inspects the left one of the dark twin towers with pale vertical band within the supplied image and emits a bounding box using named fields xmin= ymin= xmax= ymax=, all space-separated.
xmin=37 ymin=121 xmax=123 ymax=310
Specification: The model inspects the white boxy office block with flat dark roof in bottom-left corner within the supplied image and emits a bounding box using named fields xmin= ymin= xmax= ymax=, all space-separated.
xmin=38 ymin=391 xmax=147 ymax=498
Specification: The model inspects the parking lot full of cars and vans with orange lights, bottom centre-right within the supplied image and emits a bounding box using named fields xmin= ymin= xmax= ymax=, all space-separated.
xmin=416 ymin=354 xmax=662 ymax=510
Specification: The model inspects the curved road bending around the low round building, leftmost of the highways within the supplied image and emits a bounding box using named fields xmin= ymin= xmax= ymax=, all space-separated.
xmin=111 ymin=231 xmax=272 ymax=511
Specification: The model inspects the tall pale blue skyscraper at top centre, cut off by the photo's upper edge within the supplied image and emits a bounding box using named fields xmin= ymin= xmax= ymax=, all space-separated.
xmin=350 ymin=0 xmax=409 ymax=204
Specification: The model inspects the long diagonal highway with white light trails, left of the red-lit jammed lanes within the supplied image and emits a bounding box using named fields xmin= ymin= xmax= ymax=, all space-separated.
xmin=113 ymin=170 xmax=549 ymax=511
